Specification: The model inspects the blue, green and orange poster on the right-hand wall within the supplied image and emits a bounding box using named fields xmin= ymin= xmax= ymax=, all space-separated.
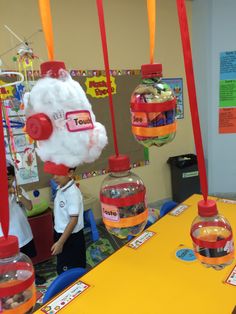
xmin=219 ymin=51 xmax=236 ymax=134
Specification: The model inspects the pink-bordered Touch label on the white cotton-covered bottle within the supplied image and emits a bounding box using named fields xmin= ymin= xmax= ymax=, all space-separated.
xmin=66 ymin=110 xmax=93 ymax=132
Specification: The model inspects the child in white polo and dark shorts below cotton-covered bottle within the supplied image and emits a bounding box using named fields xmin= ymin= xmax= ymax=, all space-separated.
xmin=46 ymin=165 xmax=86 ymax=274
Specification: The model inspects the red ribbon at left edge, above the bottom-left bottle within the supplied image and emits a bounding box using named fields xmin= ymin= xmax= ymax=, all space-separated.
xmin=0 ymin=101 xmax=9 ymax=238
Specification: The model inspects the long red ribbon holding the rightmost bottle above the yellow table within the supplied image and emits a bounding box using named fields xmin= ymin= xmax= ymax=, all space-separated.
xmin=176 ymin=0 xmax=208 ymax=201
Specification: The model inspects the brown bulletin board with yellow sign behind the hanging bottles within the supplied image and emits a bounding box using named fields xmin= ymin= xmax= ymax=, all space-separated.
xmin=2 ymin=70 xmax=183 ymax=190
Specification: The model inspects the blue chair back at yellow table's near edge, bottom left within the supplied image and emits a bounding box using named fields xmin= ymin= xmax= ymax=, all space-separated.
xmin=43 ymin=267 xmax=87 ymax=303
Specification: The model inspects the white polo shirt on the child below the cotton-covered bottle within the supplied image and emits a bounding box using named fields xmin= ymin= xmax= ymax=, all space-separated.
xmin=54 ymin=180 xmax=84 ymax=233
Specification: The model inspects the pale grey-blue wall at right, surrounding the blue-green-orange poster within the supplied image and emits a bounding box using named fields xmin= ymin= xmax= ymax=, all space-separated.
xmin=192 ymin=0 xmax=236 ymax=194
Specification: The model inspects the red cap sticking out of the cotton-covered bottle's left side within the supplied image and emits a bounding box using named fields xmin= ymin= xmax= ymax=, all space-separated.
xmin=26 ymin=113 xmax=53 ymax=141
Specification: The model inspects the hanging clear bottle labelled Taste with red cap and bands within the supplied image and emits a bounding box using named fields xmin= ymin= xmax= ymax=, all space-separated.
xmin=100 ymin=155 xmax=148 ymax=239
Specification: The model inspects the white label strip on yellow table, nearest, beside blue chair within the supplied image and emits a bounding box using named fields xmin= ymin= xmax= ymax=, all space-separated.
xmin=41 ymin=281 xmax=89 ymax=314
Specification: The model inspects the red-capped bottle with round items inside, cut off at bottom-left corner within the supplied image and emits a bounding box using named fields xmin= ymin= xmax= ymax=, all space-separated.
xmin=0 ymin=236 xmax=36 ymax=314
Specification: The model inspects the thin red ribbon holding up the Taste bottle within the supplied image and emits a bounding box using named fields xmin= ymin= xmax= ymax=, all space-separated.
xmin=96 ymin=0 xmax=119 ymax=156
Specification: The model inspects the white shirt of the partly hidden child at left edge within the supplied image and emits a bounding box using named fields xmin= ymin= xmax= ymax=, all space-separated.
xmin=0 ymin=187 xmax=33 ymax=248
